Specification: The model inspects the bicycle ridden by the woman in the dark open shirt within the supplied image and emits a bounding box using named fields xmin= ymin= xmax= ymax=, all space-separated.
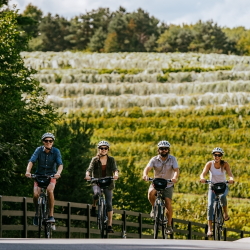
xmin=90 ymin=177 xmax=114 ymax=238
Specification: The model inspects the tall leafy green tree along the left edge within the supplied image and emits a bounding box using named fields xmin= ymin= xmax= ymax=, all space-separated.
xmin=0 ymin=4 xmax=58 ymax=195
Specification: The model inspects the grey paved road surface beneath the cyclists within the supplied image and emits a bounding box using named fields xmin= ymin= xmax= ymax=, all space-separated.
xmin=0 ymin=238 xmax=250 ymax=250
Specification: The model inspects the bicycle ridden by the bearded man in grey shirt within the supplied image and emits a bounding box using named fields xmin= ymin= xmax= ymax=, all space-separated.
xmin=149 ymin=178 xmax=171 ymax=239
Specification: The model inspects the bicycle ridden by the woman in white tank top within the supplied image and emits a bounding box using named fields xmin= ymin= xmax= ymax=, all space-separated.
xmin=206 ymin=180 xmax=228 ymax=240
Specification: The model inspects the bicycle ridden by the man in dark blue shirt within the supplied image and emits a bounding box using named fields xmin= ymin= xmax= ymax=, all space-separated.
xmin=31 ymin=174 xmax=55 ymax=238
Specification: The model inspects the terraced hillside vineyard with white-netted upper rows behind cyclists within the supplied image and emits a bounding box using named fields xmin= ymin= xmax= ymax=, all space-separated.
xmin=22 ymin=52 xmax=250 ymax=231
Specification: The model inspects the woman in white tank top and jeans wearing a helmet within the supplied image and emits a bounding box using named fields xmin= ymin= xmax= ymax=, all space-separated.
xmin=200 ymin=147 xmax=234 ymax=236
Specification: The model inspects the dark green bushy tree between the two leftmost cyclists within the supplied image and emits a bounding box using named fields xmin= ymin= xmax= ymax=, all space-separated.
xmin=55 ymin=118 xmax=93 ymax=203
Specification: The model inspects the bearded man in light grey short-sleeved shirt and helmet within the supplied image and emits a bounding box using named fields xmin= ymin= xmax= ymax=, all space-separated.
xmin=143 ymin=141 xmax=179 ymax=234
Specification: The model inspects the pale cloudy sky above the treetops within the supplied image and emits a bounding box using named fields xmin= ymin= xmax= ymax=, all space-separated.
xmin=9 ymin=0 xmax=250 ymax=29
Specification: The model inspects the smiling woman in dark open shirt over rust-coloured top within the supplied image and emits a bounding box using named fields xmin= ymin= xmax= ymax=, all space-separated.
xmin=85 ymin=141 xmax=118 ymax=233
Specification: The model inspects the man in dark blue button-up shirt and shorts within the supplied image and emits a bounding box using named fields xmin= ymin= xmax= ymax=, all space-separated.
xmin=25 ymin=133 xmax=63 ymax=226
